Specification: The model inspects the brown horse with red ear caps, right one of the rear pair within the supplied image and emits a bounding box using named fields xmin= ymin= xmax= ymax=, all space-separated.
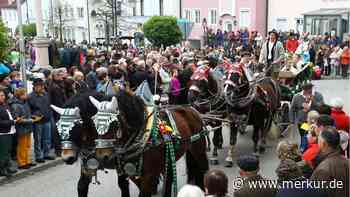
xmin=224 ymin=64 xmax=280 ymax=154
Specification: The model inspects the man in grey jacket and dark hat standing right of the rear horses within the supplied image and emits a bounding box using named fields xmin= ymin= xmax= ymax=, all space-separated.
xmin=289 ymin=82 xmax=324 ymax=152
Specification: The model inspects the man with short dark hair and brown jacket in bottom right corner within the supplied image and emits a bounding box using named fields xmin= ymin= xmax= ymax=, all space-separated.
xmin=310 ymin=127 xmax=349 ymax=197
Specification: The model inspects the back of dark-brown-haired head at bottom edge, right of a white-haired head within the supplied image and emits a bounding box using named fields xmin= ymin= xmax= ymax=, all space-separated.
xmin=204 ymin=170 xmax=228 ymax=197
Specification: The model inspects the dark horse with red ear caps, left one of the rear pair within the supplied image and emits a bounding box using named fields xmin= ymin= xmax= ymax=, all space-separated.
xmin=188 ymin=66 xmax=238 ymax=167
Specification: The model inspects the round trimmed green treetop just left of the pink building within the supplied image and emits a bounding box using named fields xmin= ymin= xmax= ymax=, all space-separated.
xmin=143 ymin=16 xmax=182 ymax=47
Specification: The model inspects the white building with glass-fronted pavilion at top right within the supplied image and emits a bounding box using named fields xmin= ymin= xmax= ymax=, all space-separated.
xmin=268 ymin=0 xmax=350 ymax=37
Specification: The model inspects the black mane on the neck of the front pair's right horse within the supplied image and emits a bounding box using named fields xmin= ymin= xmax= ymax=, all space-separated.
xmin=117 ymin=90 xmax=146 ymax=131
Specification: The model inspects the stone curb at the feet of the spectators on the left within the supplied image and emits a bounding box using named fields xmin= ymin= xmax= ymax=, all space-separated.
xmin=0 ymin=158 xmax=64 ymax=186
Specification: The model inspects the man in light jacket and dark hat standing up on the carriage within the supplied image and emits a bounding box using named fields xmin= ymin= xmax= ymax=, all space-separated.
xmin=259 ymin=30 xmax=284 ymax=80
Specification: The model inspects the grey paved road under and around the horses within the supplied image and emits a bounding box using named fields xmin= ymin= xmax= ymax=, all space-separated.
xmin=0 ymin=80 xmax=350 ymax=197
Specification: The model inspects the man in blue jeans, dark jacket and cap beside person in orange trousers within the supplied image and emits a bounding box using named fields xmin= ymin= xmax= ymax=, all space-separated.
xmin=29 ymin=78 xmax=54 ymax=163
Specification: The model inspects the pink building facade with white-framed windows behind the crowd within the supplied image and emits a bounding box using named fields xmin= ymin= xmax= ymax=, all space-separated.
xmin=182 ymin=0 xmax=267 ymax=45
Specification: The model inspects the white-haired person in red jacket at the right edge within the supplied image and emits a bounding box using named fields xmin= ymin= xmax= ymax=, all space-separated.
xmin=331 ymin=98 xmax=350 ymax=132
